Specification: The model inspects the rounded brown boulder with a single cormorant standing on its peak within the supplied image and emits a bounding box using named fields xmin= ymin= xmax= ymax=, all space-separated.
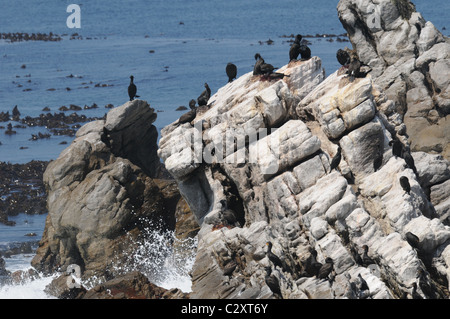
xmin=32 ymin=100 xmax=186 ymax=277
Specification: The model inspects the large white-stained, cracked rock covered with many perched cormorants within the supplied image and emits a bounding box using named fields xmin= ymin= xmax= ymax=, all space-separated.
xmin=158 ymin=46 xmax=450 ymax=298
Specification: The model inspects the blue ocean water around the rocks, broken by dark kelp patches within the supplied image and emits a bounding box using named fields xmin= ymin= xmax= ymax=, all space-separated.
xmin=0 ymin=0 xmax=450 ymax=298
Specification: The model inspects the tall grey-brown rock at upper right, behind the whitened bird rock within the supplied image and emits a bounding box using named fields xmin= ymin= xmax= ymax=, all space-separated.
xmin=337 ymin=0 xmax=450 ymax=160
